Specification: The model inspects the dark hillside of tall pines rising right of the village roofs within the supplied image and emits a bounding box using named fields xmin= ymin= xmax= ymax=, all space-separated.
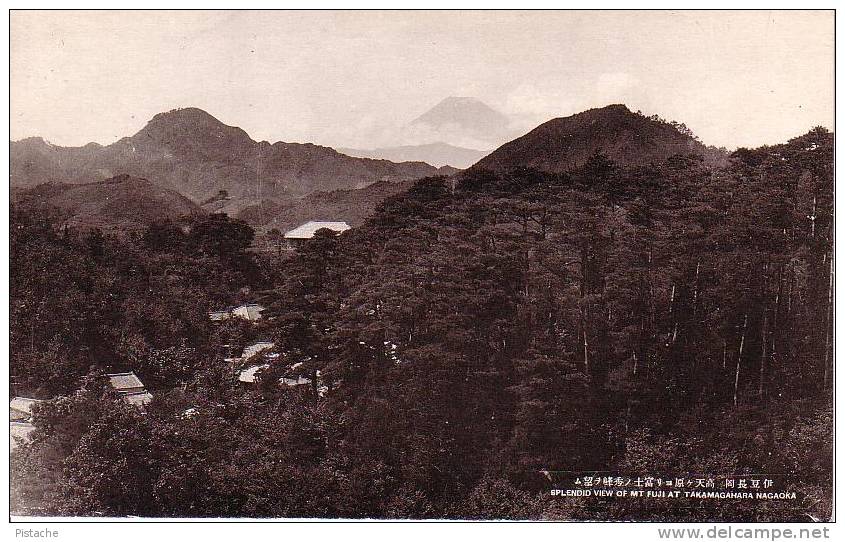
xmin=258 ymin=128 xmax=833 ymax=520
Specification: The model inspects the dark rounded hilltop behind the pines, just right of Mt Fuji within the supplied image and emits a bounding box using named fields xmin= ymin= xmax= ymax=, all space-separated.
xmin=476 ymin=104 xmax=726 ymax=173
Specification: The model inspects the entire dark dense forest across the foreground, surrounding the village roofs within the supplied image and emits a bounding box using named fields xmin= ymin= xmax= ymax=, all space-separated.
xmin=10 ymin=128 xmax=834 ymax=521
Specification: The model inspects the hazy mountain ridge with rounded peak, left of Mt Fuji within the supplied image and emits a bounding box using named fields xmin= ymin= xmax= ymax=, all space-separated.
xmin=10 ymin=108 xmax=455 ymax=214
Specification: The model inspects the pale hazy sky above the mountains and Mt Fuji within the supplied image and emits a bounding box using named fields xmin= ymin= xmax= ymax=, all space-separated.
xmin=11 ymin=11 xmax=834 ymax=148
